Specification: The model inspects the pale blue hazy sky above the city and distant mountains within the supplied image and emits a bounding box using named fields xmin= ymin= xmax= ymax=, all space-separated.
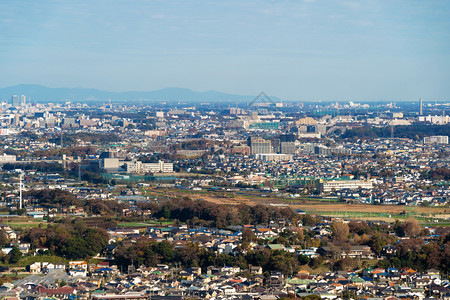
xmin=0 ymin=0 xmax=450 ymax=101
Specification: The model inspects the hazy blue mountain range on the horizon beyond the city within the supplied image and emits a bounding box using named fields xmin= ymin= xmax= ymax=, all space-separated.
xmin=0 ymin=84 xmax=278 ymax=103
